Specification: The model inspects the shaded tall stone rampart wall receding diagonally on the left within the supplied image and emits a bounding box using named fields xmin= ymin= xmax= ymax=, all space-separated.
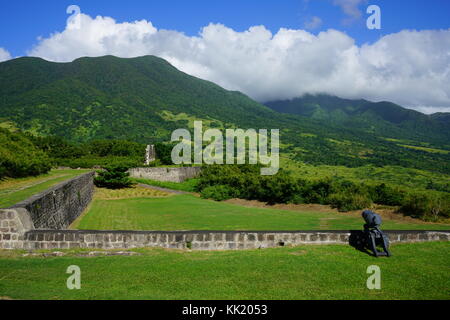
xmin=10 ymin=172 xmax=94 ymax=229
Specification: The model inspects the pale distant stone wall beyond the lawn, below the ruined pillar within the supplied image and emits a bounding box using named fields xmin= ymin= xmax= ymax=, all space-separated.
xmin=128 ymin=167 xmax=201 ymax=182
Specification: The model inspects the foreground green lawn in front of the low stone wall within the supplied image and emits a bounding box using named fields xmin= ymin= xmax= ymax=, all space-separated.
xmin=0 ymin=242 xmax=450 ymax=300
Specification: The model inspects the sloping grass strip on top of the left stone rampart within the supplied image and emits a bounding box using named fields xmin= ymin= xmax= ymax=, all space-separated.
xmin=0 ymin=169 xmax=91 ymax=208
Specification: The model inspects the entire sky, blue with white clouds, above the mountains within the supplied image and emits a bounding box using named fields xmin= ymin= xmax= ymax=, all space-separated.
xmin=0 ymin=0 xmax=450 ymax=113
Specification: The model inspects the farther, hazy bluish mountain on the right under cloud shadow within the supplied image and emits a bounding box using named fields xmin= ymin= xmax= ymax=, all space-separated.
xmin=265 ymin=94 xmax=450 ymax=143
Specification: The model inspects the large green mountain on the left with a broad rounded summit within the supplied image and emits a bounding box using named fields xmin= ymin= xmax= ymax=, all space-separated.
xmin=0 ymin=56 xmax=282 ymax=142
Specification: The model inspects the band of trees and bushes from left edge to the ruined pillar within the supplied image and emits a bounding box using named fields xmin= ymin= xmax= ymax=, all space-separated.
xmin=0 ymin=128 xmax=178 ymax=179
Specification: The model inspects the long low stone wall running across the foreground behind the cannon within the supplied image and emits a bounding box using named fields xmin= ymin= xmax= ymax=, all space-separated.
xmin=0 ymin=229 xmax=450 ymax=250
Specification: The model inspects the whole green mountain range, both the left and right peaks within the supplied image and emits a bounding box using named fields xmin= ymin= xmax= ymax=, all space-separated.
xmin=0 ymin=56 xmax=450 ymax=172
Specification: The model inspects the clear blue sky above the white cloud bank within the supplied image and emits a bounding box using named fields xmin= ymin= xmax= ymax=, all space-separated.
xmin=0 ymin=0 xmax=450 ymax=56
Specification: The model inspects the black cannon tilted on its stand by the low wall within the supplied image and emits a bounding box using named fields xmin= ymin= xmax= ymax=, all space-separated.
xmin=362 ymin=210 xmax=391 ymax=257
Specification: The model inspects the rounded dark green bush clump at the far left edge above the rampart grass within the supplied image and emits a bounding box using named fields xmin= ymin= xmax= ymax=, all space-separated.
xmin=0 ymin=128 xmax=51 ymax=179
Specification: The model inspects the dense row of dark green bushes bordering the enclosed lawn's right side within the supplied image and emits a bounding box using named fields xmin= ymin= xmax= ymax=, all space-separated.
xmin=196 ymin=165 xmax=450 ymax=221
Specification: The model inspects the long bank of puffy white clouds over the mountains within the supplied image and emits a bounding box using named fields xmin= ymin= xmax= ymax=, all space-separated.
xmin=29 ymin=15 xmax=450 ymax=110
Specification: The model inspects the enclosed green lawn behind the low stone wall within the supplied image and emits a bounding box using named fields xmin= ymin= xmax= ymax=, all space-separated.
xmin=73 ymin=195 xmax=450 ymax=230
